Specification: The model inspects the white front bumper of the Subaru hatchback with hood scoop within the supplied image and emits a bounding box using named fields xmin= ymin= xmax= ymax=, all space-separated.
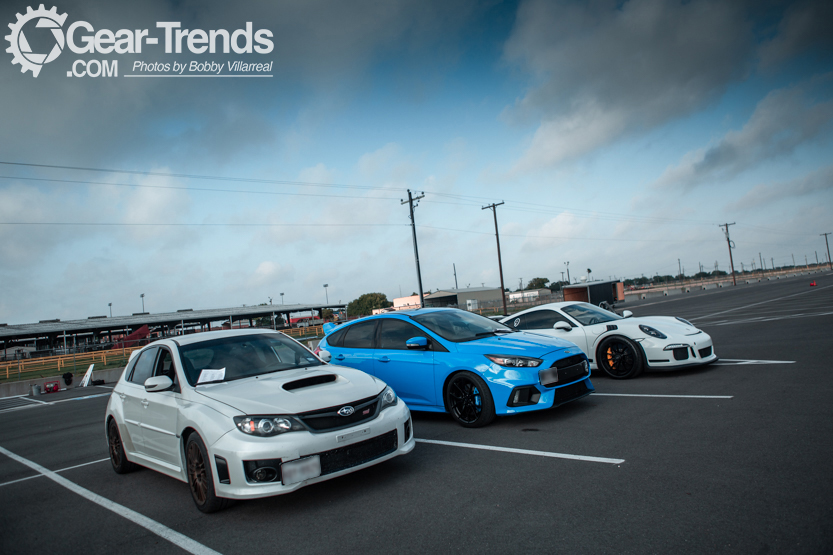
xmin=208 ymin=400 xmax=415 ymax=499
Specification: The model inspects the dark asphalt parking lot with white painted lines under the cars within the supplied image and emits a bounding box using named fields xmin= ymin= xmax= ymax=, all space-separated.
xmin=0 ymin=273 xmax=833 ymax=554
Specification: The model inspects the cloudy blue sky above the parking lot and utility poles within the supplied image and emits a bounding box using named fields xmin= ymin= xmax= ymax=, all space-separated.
xmin=0 ymin=0 xmax=833 ymax=324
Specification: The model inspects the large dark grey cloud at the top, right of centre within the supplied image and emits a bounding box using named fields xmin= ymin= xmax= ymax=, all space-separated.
xmin=504 ymin=0 xmax=753 ymax=171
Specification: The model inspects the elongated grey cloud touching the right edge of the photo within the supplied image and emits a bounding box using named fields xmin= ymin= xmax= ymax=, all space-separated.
xmin=653 ymin=85 xmax=833 ymax=189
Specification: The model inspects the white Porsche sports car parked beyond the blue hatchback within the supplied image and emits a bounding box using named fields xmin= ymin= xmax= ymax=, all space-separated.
xmin=501 ymin=301 xmax=717 ymax=379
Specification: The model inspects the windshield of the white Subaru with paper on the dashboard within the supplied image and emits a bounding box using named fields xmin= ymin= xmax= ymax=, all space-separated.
xmin=179 ymin=334 xmax=322 ymax=385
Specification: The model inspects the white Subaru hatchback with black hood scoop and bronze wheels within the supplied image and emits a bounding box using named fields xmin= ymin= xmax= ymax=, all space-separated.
xmin=105 ymin=330 xmax=414 ymax=512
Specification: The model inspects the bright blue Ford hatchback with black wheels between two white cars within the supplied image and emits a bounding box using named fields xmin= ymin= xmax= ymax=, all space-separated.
xmin=317 ymin=308 xmax=595 ymax=428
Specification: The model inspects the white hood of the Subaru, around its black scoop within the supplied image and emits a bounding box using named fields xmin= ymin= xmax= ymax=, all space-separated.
xmin=196 ymin=364 xmax=385 ymax=415
